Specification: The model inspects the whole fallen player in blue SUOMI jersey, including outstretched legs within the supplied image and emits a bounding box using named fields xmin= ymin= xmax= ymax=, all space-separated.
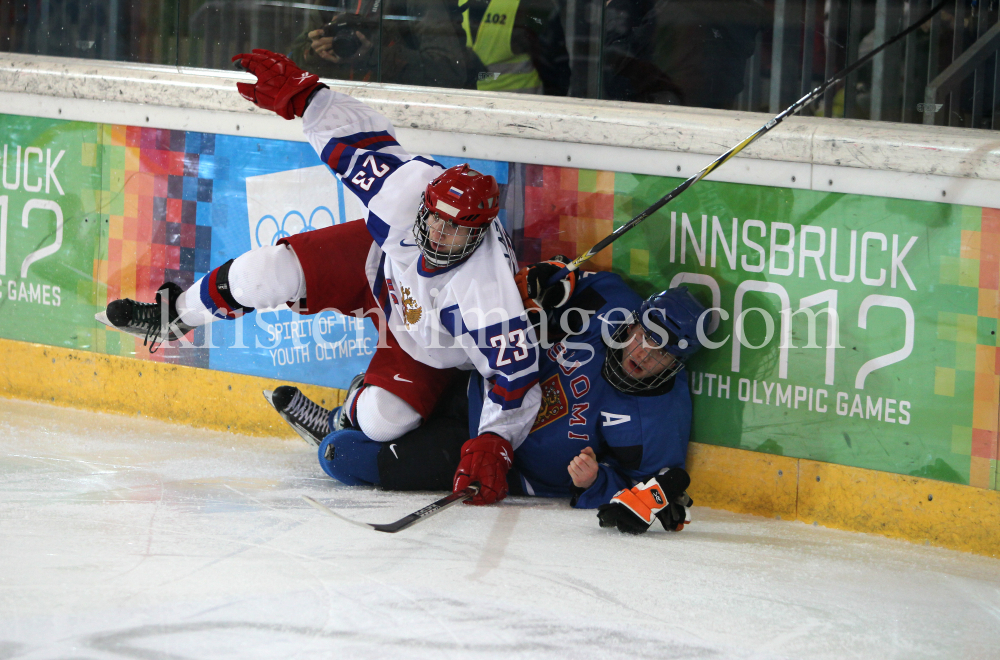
xmin=278 ymin=263 xmax=705 ymax=533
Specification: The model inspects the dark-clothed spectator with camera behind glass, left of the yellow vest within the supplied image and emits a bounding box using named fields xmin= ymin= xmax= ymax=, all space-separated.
xmin=290 ymin=0 xmax=476 ymax=87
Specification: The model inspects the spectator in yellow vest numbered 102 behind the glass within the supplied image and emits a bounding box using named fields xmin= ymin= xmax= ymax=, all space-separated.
xmin=459 ymin=0 xmax=570 ymax=96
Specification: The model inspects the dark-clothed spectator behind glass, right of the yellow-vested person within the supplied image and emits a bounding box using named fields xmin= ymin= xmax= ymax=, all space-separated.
xmin=603 ymin=0 xmax=768 ymax=109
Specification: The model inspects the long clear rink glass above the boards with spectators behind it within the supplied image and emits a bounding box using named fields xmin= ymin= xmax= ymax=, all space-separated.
xmin=0 ymin=0 xmax=1000 ymax=129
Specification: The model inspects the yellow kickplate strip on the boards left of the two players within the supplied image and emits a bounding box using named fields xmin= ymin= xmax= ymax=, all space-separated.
xmin=0 ymin=339 xmax=344 ymax=438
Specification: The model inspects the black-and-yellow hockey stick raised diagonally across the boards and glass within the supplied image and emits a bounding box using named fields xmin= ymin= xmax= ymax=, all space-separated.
xmin=548 ymin=0 xmax=950 ymax=286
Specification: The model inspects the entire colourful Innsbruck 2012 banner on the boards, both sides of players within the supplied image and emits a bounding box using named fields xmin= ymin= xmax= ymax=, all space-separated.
xmin=0 ymin=115 xmax=1000 ymax=488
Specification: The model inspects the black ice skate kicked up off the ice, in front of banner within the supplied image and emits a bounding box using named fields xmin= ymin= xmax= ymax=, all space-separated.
xmin=94 ymin=282 xmax=194 ymax=353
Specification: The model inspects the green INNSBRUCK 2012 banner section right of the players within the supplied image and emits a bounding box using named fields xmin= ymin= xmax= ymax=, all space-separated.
xmin=613 ymin=174 xmax=1000 ymax=488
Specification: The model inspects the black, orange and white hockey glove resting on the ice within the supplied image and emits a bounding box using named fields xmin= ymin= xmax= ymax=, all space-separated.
xmin=597 ymin=468 xmax=693 ymax=534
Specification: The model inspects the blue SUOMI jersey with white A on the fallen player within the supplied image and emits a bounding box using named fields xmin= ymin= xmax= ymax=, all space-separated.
xmin=469 ymin=273 xmax=691 ymax=508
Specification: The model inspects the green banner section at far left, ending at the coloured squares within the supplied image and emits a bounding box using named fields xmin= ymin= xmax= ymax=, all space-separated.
xmin=0 ymin=115 xmax=102 ymax=349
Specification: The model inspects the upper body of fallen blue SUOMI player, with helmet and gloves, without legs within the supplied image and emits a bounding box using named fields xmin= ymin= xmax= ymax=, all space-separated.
xmin=470 ymin=262 xmax=705 ymax=533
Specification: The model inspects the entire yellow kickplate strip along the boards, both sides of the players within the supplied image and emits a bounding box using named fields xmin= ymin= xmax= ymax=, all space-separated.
xmin=0 ymin=339 xmax=1000 ymax=557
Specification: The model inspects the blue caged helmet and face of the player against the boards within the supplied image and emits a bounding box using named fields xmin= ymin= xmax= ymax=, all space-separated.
xmin=601 ymin=286 xmax=705 ymax=396
